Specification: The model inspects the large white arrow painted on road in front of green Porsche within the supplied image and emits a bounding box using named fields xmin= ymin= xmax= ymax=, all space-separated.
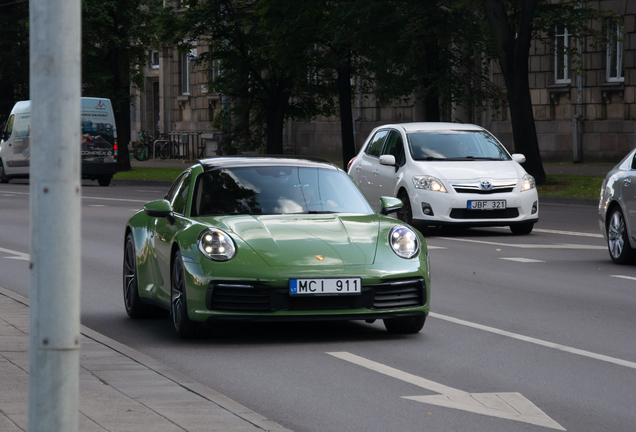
xmin=327 ymin=352 xmax=565 ymax=430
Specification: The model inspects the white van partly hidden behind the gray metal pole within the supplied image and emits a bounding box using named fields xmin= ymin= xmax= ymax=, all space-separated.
xmin=0 ymin=98 xmax=117 ymax=186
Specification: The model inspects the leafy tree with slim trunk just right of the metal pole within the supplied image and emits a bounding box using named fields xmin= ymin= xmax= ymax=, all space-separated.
xmin=82 ymin=0 xmax=162 ymax=171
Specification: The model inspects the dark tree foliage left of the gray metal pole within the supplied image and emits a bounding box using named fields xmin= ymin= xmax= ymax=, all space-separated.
xmin=0 ymin=0 xmax=29 ymax=127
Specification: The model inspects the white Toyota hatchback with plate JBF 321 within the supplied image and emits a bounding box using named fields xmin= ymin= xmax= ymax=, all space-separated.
xmin=347 ymin=123 xmax=539 ymax=234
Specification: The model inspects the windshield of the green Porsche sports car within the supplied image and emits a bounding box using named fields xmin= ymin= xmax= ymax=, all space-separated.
xmin=192 ymin=166 xmax=373 ymax=216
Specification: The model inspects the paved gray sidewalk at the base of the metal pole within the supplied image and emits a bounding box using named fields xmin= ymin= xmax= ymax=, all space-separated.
xmin=0 ymin=288 xmax=289 ymax=432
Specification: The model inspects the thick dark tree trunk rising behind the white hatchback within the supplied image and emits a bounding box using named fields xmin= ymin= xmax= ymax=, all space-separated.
xmin=482 ymin=0 xmax=546 ymax=184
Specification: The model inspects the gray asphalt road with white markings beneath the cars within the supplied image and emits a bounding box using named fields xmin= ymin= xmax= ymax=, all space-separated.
xmin=0 ymin=182 xmax=636 ymax=432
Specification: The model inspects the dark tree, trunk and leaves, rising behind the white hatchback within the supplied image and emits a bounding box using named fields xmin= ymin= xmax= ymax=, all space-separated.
xmin=474 ymin=0 xmax=617 ymax=184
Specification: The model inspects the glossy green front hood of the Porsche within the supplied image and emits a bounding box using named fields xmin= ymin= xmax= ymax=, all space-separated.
xmin=217 ymin=214 xmax=379 ymax=266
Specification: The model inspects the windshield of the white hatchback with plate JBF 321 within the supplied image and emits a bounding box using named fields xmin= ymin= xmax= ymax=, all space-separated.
xmin=408 ymin=130 xmax=510 ymax=161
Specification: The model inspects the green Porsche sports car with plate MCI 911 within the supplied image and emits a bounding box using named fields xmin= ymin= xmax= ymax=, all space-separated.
xmin=123 ymin=157 xmax=430 ymax=338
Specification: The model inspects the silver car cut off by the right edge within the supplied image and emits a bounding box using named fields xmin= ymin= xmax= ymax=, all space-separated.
xmin=598 ymin=149 xmax=636 ymax=264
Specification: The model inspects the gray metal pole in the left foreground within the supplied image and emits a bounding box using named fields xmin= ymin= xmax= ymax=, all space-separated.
xmin=29 ymin=0 xmax=81 ymax=432
